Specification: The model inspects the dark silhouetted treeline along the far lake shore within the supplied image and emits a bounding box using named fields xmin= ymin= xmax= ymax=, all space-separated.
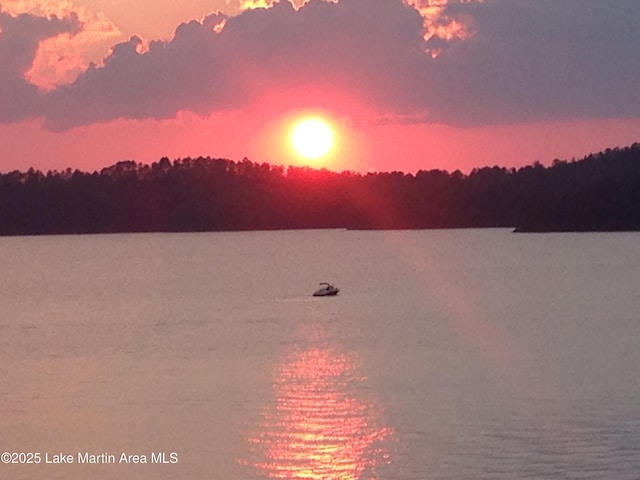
xmin=0 ymin=144 xmax=640 ymax=235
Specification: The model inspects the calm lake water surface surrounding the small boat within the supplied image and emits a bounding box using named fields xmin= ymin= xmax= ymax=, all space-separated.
xmin=0 ymin=230 xmax=640 ymax=480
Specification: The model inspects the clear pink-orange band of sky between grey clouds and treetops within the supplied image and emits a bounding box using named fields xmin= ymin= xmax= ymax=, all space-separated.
xmin=5 ymin=113 xmax=640 ymax=172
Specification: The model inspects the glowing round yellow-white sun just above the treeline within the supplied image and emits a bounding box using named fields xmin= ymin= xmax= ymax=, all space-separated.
xmin=290 ymin=117 xmax=335 ymax=160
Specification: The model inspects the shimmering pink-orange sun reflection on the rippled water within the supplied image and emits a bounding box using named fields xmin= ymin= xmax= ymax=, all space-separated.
xmin=250 ymin=348 xmax=389 ymax=480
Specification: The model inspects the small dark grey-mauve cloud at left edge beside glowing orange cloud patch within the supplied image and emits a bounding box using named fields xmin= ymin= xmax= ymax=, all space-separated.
xmin=0 ymin=11 xmax=80 ymax=122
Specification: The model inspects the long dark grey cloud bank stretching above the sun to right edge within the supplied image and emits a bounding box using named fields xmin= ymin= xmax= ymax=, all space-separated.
xmin=3 ymin=0 xmax=640 ymax=130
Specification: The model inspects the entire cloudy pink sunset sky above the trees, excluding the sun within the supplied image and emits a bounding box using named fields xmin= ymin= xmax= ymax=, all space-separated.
xmin=0 ymin=0 xmax=640 ymax=172
